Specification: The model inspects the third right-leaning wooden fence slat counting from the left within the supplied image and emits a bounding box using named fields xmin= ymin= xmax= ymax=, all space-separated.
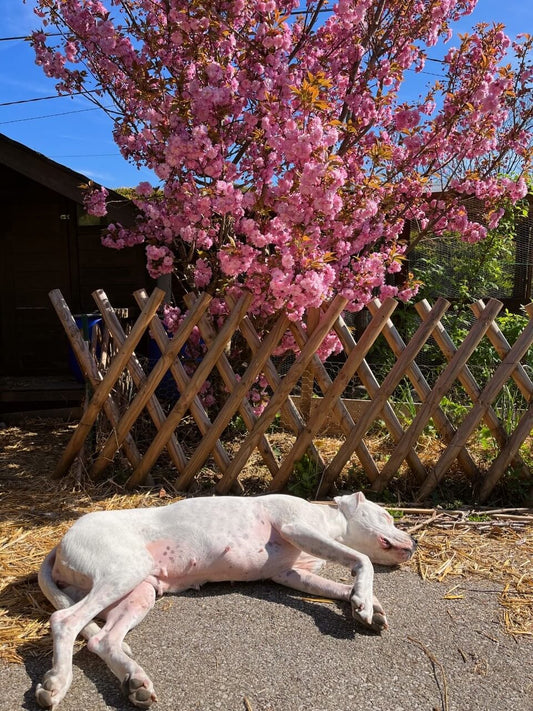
xmin=126 ymin=294 xmax=251 ymax=487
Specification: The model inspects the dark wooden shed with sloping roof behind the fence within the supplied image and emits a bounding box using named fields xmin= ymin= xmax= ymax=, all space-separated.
xmin=0 ymin=134 xmax=149 ymax=414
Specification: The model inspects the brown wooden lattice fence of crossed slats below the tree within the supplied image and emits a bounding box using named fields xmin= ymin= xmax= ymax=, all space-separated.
xmin=50 ymin=289 xmax=533 ymax=501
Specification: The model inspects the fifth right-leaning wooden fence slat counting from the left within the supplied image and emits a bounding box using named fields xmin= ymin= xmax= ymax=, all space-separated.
xmin=216 ymin=296 xmax=346 ymax=494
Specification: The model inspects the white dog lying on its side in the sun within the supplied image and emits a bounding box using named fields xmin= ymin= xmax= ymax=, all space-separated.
xmin=36 ymin=493 xmax=416 ymax=709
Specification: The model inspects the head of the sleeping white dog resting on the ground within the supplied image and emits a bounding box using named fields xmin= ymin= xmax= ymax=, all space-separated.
xmin=335 ymin=491 xmax=416 ymax=565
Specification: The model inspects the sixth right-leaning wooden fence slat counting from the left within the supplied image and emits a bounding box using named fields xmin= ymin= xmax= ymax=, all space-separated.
xmin=271 ymin=299 xmax=397 ymax=489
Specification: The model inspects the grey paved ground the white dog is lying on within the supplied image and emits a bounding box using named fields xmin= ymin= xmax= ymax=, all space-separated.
xmin=0 ymin=565 xmax=533 ymax=711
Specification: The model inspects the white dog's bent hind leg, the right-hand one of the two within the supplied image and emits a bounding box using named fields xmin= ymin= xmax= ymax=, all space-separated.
xmin=87 ymin=581 xmax=157 ymax=708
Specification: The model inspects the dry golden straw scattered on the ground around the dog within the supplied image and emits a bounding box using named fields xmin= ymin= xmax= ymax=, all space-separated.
xmin=0 ymin=421 xmax=533 ymax=662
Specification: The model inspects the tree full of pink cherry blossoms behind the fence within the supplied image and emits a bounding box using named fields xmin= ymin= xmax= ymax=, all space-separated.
xmin=32 ymin=0 xmax=533 ymax=326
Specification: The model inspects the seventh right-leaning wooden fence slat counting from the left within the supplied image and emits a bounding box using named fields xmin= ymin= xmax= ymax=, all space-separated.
xmin=317 ymin=298 xmax=449 ymax=496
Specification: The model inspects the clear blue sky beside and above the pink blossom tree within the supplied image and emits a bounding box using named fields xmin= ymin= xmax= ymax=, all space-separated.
xmin=0 ymin=0 xmax=533 ymax=188
